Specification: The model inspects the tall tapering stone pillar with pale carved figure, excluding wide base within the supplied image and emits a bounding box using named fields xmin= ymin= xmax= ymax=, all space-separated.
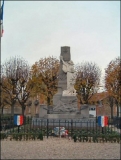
xmin=53 ymin=46 xmax=78 ymax=114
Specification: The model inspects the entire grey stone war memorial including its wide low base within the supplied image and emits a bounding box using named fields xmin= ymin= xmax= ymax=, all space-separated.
xmin=39 ymin=46 xmax=89 ymax=119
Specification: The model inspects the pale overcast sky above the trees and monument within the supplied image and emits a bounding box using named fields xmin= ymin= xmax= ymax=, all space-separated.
xmin=1 ymin=1 xmax=120 ymax=90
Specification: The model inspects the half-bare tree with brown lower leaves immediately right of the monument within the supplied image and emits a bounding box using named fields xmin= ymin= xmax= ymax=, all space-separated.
xmin=74 ymin=62 xmax=101 ymax=104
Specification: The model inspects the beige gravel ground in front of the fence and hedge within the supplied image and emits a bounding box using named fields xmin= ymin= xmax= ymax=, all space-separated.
xmin=1 ymin=138 xmax=120 ymax=160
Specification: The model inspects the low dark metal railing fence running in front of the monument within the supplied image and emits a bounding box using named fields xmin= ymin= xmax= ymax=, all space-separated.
xmin=0 ymin=117 xmax=121 ymax=138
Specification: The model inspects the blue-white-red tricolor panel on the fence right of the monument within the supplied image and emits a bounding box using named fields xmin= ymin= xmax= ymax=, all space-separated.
xmin=98 ymin=116 xmax=108 ymax=127
